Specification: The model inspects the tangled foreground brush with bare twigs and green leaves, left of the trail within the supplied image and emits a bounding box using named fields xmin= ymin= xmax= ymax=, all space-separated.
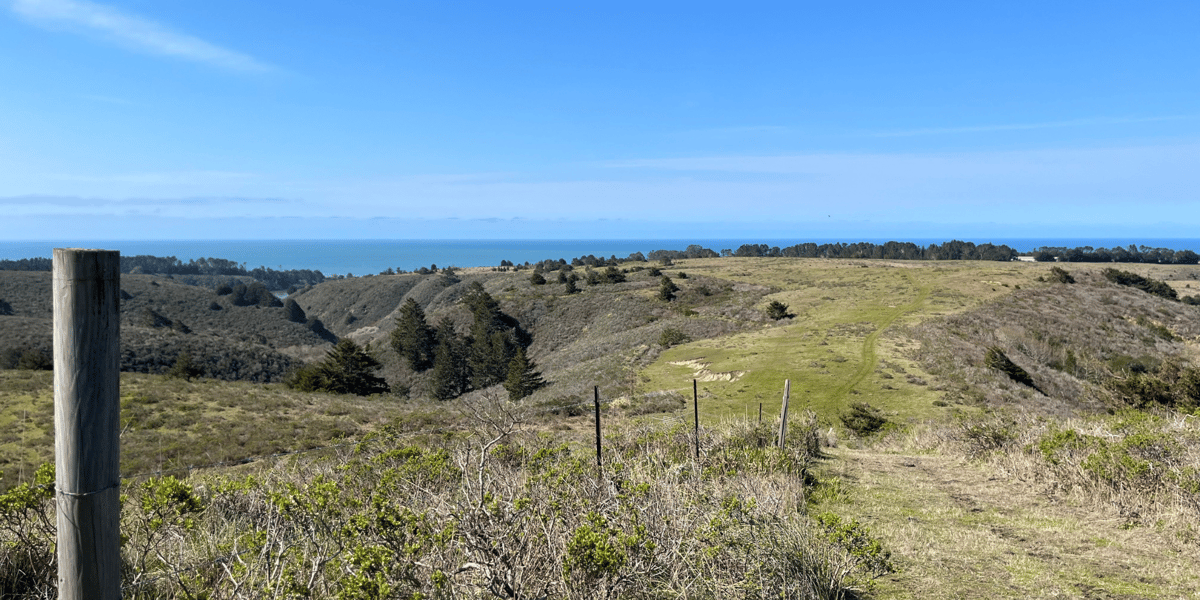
xmin=0 ymin=397 xmax=890 ymax=599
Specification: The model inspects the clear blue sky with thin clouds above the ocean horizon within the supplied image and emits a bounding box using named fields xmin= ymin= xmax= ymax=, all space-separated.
xmin=0 ymin=0 xmax=1200 ymax=241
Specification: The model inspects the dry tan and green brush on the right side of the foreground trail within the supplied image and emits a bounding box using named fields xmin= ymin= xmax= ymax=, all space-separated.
xmin=883 ymin=408 xmax=1200 ymax=545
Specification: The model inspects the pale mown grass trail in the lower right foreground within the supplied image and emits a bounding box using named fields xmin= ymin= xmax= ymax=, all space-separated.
xmin=822 ymin=449 xmax=1200 ymax=600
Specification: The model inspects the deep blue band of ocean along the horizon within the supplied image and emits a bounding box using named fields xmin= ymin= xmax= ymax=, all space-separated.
xmin=0 ymin=238 xmax=1200 ymax=275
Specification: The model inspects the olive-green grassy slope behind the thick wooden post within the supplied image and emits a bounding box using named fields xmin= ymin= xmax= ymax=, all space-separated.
xmin=0 ymin=371 xmax=430 ymax=490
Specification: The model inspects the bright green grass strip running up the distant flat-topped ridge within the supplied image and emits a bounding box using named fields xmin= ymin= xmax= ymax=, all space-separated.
xmin=640 ymin=258 xmax=1045 ymax=422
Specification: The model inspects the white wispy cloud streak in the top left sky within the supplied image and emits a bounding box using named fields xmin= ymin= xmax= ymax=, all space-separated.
xmin=11 ymin=0 xmax=276 ymax=73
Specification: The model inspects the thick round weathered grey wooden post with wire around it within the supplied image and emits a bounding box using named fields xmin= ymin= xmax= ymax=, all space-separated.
xmin=53 ymin=248 xmax=121 ymax=600
